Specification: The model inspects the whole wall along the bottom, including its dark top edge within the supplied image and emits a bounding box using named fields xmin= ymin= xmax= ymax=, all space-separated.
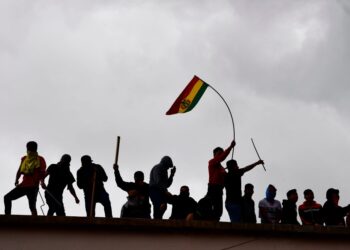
xmin=0 ymin=216 xmax=350 ymax=250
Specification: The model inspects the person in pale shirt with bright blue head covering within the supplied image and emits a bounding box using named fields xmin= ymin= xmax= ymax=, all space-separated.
xmin=259 ymin=184 xmax=282 ymax=224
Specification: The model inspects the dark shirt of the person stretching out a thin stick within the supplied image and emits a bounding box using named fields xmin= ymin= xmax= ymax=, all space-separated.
xmin=225 ymin=169 xmax=244 ymax=203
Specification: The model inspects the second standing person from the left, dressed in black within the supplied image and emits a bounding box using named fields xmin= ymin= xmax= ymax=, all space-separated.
xmin=42 ymin=154 xmax=79 ymax=216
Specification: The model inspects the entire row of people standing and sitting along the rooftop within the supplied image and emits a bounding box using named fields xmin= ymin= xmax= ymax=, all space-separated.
xmin=4 ymin=141 xmax=350 ymax=226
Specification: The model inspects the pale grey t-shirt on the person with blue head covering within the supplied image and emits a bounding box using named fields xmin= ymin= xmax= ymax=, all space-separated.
xmin=259 ymin=198 xmax=282 ymax=223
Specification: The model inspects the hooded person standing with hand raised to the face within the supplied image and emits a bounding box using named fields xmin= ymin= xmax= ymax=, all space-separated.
xmin=149 ymin=156 xmax=176 ymax=219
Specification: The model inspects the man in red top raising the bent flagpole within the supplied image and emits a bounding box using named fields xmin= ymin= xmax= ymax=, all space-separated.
xmin=207 ymin=141 xmax=236 ymax=221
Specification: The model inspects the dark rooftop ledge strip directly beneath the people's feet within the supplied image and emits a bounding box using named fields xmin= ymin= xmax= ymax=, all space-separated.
xmin=0 ymin=215 xmax=350 ymax=240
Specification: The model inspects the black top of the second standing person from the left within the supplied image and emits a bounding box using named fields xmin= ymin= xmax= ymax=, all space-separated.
xmin=47 ymin=164 xmax=75 ymax=195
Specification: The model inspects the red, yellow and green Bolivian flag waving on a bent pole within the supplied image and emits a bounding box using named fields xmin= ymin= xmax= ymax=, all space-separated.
xmin=166 ymin=76 xmax=209 ymax=115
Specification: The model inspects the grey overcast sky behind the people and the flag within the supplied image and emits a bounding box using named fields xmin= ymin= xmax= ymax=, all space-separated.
xmin=0 ymin=0 xmax=350 ymax=221
